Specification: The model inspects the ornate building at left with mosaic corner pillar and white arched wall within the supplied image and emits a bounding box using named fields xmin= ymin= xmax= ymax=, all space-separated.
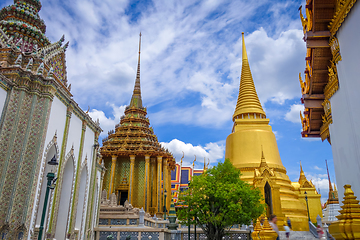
xmin=0 ymin=0 xmax=104 ymax=240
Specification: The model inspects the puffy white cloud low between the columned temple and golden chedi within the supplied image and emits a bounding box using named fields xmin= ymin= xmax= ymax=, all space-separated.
xmin=161 ymin=139 xmax=225 ymax=168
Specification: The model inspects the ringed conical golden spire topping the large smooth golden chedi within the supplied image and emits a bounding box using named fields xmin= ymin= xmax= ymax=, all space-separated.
xmin=233 ymin=33 xmax=266 ymax=120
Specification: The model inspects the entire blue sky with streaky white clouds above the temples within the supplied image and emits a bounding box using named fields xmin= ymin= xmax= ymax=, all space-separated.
xmin=2 ymin=0 xmax=334 ymax=202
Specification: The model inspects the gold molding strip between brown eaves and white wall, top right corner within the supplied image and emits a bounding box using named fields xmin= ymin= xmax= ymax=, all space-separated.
xmin=329 ymin=0 xmax=356 ymax=36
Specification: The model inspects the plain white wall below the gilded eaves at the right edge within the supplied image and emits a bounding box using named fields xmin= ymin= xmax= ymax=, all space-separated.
xmin=330 ymin=2 xmax=360 ymax=204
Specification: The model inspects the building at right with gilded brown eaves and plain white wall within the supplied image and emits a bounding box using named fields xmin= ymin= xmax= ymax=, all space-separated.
xmin=300 ymin=0 xmax=360 ymax=202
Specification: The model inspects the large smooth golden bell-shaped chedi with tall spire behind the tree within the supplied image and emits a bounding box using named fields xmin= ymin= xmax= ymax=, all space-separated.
xmin=225 ymin=34 xmax=309 ymax=231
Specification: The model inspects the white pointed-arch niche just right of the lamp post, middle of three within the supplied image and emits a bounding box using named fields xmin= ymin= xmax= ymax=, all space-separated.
xmin=55 ymin=155 xmax=75 ymax=239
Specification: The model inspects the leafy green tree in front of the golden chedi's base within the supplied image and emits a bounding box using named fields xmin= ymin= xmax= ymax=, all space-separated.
xmin=178 ymin=159 xmax=264 ymax=240
